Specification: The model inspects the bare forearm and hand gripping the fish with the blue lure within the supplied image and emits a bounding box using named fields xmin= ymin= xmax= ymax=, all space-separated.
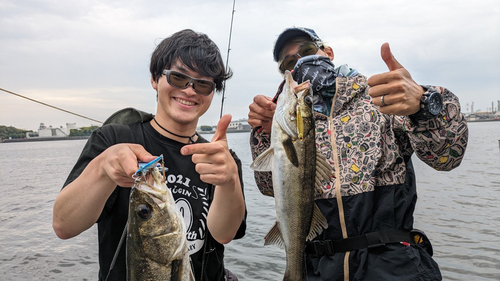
xmin=52 ymin=143 xmax=155 ymax=239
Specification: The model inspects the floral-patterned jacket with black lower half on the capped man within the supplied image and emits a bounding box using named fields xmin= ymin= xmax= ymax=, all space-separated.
xmin=250 ymin=74 xmax=468 ymax=280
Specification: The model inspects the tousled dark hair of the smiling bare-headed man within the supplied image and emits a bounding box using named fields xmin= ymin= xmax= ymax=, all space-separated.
xmin=149 ymin=29 xmax=233 ymax=92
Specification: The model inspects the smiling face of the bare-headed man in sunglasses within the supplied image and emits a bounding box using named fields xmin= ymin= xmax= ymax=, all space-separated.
xmin=151 ymin=60 xmax=214 ymax=131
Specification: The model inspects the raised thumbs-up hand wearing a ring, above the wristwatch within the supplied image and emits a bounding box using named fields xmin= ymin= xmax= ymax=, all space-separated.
xmin=368 ymin=43 xmax=425 ymax=115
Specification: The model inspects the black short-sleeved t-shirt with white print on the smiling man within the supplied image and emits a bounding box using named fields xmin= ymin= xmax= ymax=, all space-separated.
xmin=64 ymin=122 xmax=246 ymax=280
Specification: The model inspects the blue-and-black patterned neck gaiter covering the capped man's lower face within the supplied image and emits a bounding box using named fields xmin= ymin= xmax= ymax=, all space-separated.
xmin=292 ymin=55 xmax=337 ymax=115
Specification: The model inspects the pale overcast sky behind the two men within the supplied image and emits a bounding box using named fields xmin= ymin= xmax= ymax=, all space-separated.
xmin=0 ymin=0 xmax=500 ymax=130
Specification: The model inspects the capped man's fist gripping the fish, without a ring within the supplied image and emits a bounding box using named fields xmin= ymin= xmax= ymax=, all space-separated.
xmin=248 ymin=95 xmax=276 ymax=134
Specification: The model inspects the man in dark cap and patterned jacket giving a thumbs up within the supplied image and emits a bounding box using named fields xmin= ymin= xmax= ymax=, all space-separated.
xmin=248 ymin=27 xmax=468 ymax=280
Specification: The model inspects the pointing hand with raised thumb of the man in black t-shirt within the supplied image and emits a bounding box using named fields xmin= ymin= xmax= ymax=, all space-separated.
xmin=181 ymin=114 xmax=239 ymax=187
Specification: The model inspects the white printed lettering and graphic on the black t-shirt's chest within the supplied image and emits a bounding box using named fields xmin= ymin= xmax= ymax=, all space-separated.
xmin=167 ymin=174 xmax=208 ymax=255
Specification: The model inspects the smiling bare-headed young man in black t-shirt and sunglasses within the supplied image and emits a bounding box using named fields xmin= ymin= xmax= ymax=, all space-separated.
xmin=53 ymin=30 xmax=246 ymax=280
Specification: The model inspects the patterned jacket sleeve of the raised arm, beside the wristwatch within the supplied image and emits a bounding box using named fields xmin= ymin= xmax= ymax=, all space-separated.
xmin=395 ymin=86 xmax=469 ymax=171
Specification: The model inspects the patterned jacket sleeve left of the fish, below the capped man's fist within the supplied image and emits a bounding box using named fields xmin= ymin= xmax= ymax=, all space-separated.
xmin=250 ymin=127 xmax=274 ymax=196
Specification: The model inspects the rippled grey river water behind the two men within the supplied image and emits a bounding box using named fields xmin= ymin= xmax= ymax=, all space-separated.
xmin=0 ymin=122 xmax=500 ymax=281
